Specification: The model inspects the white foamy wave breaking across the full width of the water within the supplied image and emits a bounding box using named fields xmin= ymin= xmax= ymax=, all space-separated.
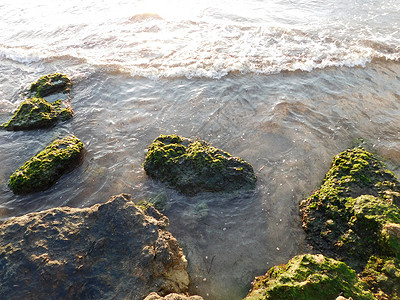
xmin=0 ymin=20 xmax=400 ymax=79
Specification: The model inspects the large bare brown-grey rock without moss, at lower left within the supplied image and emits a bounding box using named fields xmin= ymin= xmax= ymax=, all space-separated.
xmin=0 ymin=194 xmax=189 ymax=300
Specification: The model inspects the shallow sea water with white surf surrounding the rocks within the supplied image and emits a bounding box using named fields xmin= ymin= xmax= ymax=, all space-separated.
xmin=0 ymin=0 xmax=400 ymax=300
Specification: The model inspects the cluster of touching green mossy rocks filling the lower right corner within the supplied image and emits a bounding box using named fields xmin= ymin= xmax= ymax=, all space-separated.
xmin=246 ymin=148 xmax=400 ymax=300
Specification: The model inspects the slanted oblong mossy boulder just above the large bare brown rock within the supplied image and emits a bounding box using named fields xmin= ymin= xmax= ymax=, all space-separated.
xmin=9 ymin=136 xmax=83 ymax=194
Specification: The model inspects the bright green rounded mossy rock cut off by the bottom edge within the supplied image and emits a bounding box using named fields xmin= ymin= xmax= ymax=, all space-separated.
xmin=245 ymin=254 xmax=374 ymax=300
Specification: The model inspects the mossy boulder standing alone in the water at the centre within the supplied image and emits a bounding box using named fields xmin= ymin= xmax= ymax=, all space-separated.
xmin=143 ymin=135 xmax=256 ymax=195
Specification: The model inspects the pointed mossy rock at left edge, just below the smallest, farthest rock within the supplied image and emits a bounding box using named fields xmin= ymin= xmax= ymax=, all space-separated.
xmin=1 ymin=98 xmax=73 ymax=130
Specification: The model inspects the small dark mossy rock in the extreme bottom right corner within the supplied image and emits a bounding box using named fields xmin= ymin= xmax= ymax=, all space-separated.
xmin=360 ymin=256 xmax=400 ymax=300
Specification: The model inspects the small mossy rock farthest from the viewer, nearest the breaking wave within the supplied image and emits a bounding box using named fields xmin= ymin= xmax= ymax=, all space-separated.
xmin=29 ymin=73 xmax=72 ymax=97
